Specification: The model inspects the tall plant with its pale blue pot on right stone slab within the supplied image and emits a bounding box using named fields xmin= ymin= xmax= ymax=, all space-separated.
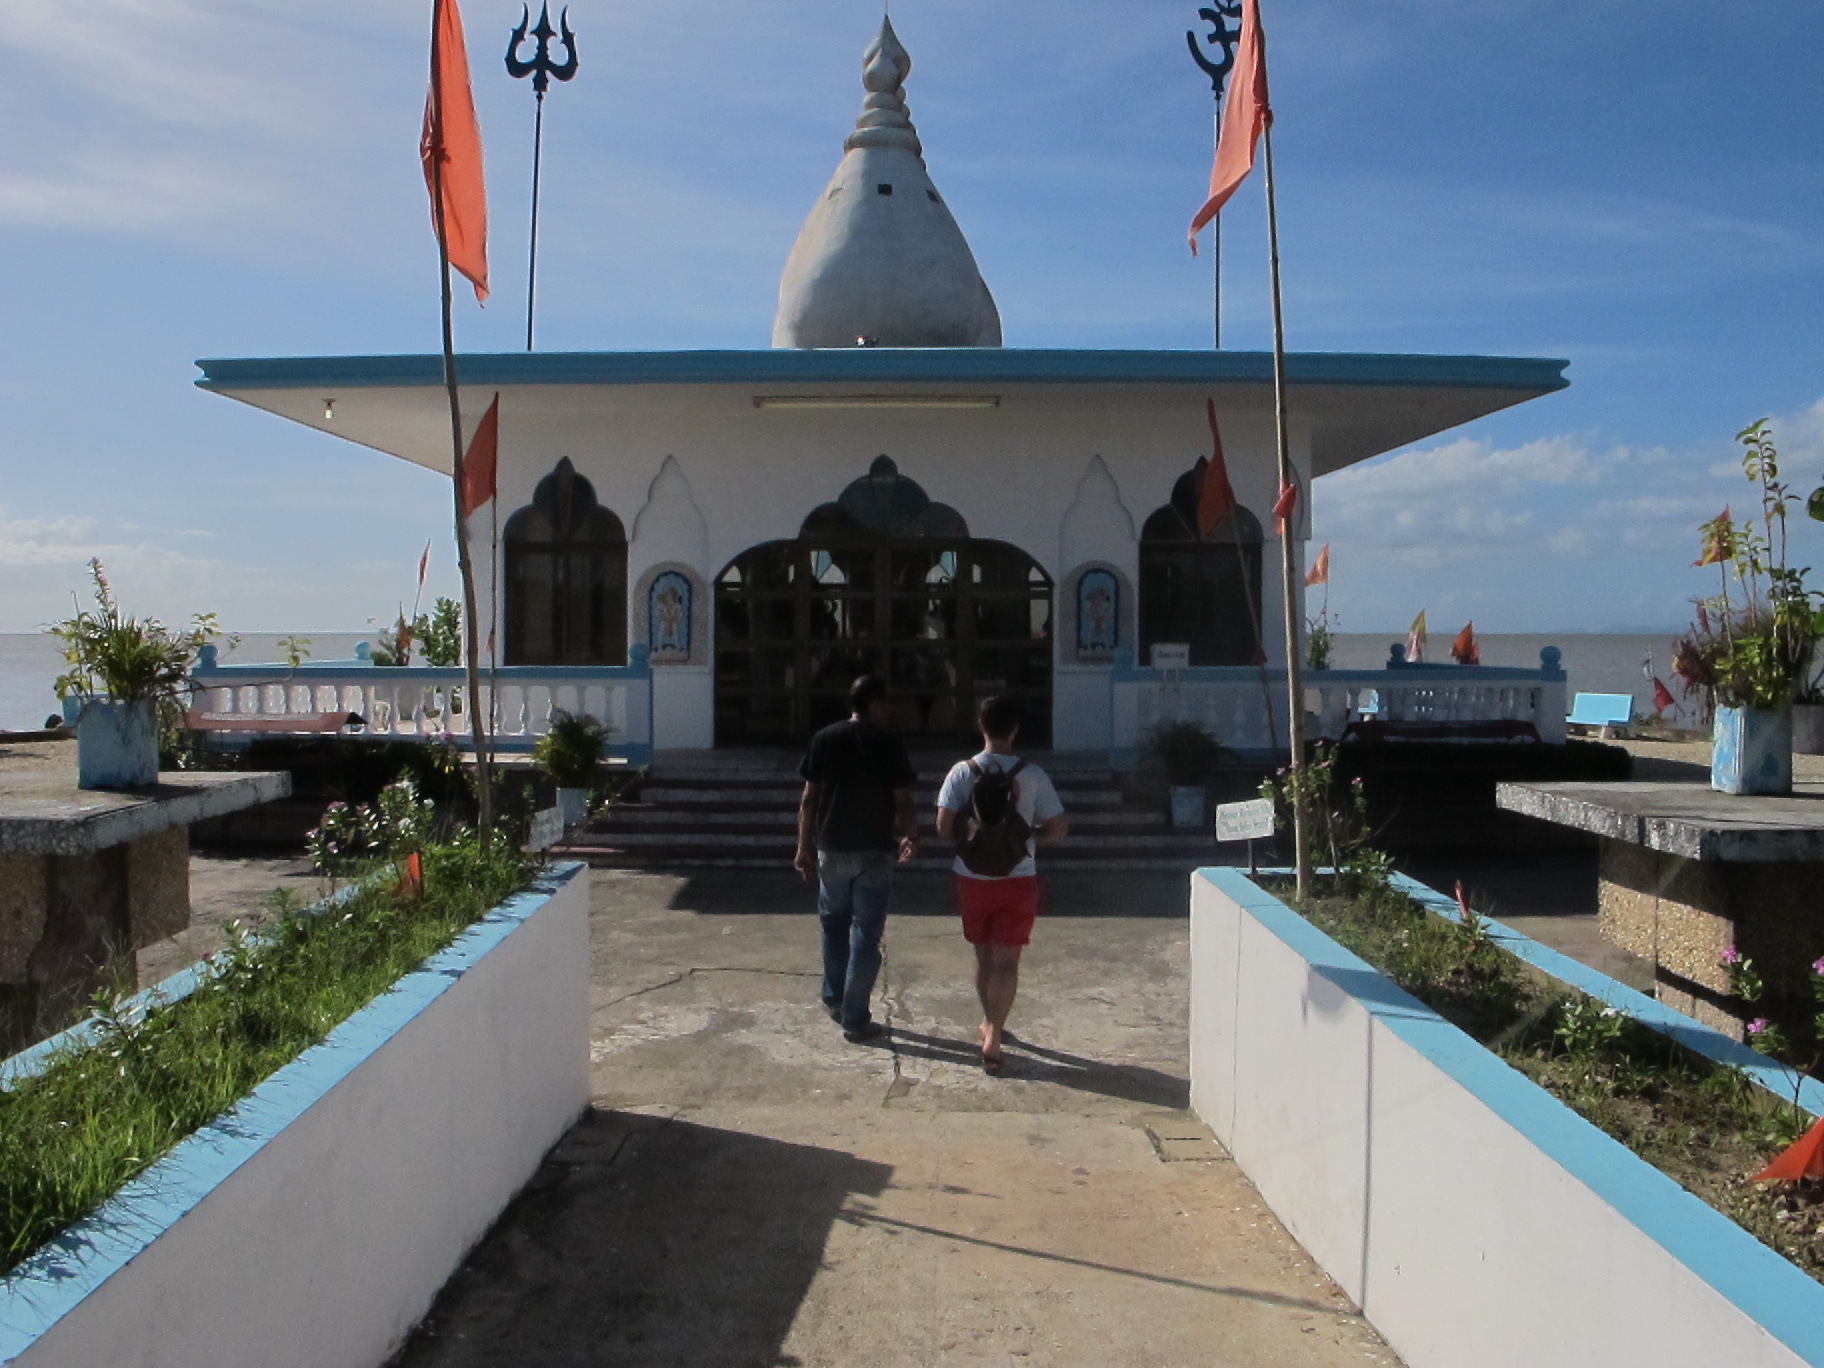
xmin=1676 ymin=420 xmax=1819 ymax=793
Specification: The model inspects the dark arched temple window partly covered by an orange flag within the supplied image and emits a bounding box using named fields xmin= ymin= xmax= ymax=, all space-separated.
xmin=1140 ymin=461 xmax=1264 ymax=666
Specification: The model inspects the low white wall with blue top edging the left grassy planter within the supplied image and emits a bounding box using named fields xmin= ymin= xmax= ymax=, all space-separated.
xmin=0 ymin=866 xmax=589 ymax=1368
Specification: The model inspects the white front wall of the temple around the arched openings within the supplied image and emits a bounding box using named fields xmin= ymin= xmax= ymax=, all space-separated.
xmin=471 ymin=385 xmax=1310 ymax=750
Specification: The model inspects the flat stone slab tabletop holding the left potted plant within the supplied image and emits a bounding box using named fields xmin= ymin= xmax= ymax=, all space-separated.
xmin=0 ymin=741 xmax=292 ymax=855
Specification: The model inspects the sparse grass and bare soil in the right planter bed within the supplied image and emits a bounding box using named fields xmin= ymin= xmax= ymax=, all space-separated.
xmin=1262 ymin=879 xmax=1824 ymax=1280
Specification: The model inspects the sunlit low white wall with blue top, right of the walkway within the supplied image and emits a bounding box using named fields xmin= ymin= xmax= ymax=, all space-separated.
xmin=1191 ymin=870 xmax=1824 ymax=1368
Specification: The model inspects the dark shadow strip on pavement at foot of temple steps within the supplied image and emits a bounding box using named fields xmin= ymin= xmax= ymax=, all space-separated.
xmin=669 ymin=865 xmax=1191 ymax=919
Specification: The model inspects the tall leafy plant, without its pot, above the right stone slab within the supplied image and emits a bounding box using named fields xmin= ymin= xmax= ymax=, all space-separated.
xmin=1673 ymin=420 xmax=1824 ymax=708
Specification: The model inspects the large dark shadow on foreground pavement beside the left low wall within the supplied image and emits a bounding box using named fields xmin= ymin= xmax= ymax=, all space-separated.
xmin=390 ymin=1109 xmax=892 ymax=1368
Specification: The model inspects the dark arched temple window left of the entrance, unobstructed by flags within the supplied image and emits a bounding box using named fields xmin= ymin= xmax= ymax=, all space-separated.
xmin=500 ymin=456 xmax=627 ymax=666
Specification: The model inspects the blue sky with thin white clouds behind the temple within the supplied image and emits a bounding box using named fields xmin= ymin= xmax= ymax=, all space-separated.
xmin=0 ymin=0 xmax=1824 ymax=633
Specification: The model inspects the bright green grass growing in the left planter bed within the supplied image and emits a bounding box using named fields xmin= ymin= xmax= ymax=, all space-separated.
xmin=0 ymin=837 xmax=531 ymax=1271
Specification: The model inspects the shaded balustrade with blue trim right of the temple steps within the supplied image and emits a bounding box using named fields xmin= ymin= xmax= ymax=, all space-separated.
xmin=1109 ymin=646 xmax=1565 ymax=768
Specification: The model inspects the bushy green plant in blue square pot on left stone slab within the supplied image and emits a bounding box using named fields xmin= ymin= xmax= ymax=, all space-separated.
xmin=46 ymin=560 xmax=221 ymax=788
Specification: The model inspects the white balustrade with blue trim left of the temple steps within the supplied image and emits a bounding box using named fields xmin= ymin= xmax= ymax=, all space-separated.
xmin=190 ymin=644 xmax=653 ymax=764
